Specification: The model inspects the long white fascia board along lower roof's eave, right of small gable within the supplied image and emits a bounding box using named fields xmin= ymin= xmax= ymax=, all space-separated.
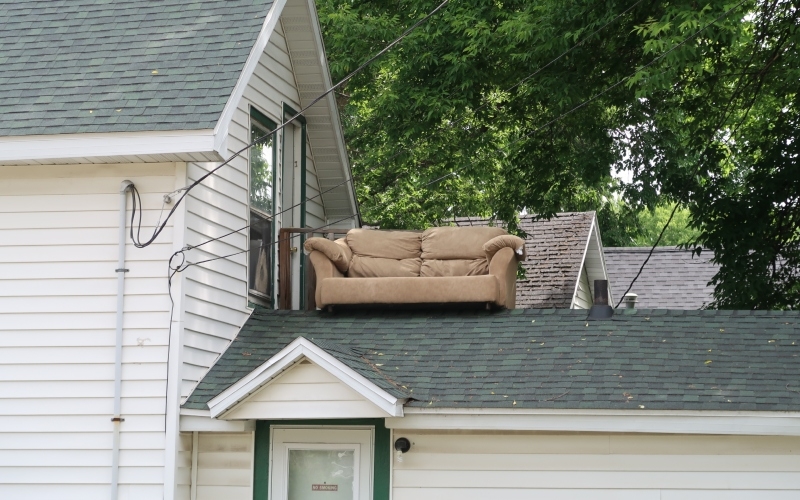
xmin=386 ymin=408 xmax=800 ymax=436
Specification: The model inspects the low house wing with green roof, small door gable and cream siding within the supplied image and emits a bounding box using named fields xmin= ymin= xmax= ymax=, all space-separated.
xmin=181 ymin=308 xmax=800 ymax=500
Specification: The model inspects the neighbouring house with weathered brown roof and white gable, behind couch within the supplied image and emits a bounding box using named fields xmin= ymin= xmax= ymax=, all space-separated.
xmin=456 ymin=212 xmax=616 ymax=309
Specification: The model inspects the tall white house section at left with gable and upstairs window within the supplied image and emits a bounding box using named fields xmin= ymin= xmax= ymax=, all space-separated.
xmin=0 ymin=0 xmax=358 ymax=500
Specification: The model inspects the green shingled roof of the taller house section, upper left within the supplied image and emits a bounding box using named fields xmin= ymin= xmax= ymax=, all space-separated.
xmin=0 ymin=0 xmax=272 ymax=136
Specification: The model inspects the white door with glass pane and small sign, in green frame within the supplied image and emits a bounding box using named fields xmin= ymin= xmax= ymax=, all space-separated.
xmin=269 ymin=427 xmax=374 ymax=500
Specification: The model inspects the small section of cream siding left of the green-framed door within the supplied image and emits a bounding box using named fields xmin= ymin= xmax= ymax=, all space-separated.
xmin=194 ymin=432 xmax=255 ymax=500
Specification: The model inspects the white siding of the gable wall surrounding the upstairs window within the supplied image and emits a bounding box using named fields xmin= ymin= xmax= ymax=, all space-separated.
xmin=181 ymin=22 xmax=310 ymax=402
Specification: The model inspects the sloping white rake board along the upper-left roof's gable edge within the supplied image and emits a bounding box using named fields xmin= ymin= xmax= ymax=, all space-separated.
xmin=214 ymin=0 xmax=286 ymax=157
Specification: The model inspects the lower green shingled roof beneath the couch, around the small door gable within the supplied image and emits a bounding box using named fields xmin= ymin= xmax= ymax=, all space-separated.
xmin=184 ymin=308 xmax=800 ymax=411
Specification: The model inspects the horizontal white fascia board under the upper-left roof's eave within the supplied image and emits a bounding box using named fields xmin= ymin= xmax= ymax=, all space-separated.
xmin=0 ymin=130 xmax=219 ymax=161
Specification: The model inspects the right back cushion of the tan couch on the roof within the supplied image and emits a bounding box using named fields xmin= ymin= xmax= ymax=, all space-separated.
xmin=421 ymin=227 xmax=508 ymax=260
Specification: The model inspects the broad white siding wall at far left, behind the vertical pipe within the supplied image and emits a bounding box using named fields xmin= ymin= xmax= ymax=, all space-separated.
xmin=0 ymin=163 xmax=177 ymax=500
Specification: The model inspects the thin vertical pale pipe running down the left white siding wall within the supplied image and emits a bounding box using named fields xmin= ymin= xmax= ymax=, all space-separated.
xmin=111 ymin=180 xmax=133 ymax=500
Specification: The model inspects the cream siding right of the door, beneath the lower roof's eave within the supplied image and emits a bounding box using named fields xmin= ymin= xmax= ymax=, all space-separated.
xmin=392 ymin=431 xmax=800 ymax=500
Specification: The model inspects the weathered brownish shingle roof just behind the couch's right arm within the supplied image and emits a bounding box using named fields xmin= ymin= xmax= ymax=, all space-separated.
xmin=456 ymin=212 xmax=594 ymax=309
